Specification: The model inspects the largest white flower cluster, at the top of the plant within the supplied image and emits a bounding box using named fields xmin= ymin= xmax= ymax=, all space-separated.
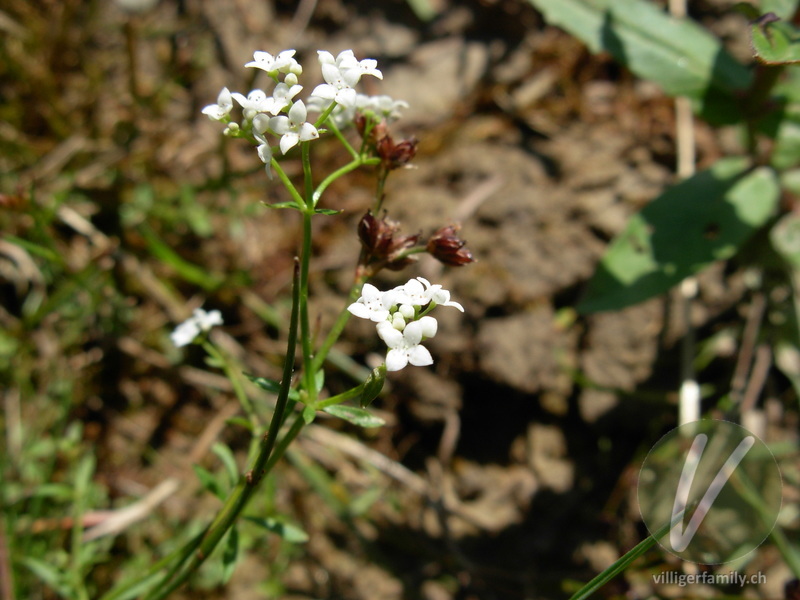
xmin=203 ymin=50 xmax=400 ymax=177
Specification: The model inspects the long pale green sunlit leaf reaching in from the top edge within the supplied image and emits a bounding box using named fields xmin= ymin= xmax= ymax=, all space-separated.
xmin=529 ymin=0 xmax=752 ymax=124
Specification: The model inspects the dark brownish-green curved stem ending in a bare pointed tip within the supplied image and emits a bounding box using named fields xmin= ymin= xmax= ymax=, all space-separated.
xmin=141 ymin=262 xmax=300 ymax=600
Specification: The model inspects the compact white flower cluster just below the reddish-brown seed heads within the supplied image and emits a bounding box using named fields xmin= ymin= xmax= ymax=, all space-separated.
xmin=347 ymin=277 xmax=464 ymax=371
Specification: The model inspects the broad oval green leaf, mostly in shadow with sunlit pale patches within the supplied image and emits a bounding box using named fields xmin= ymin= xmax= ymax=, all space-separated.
xmin=578 ymin=158 xmax=779 ymax=313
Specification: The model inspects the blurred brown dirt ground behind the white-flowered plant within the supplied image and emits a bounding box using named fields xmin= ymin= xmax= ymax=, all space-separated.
xmin=2 ymin=0 xmax=796 ymax=600
